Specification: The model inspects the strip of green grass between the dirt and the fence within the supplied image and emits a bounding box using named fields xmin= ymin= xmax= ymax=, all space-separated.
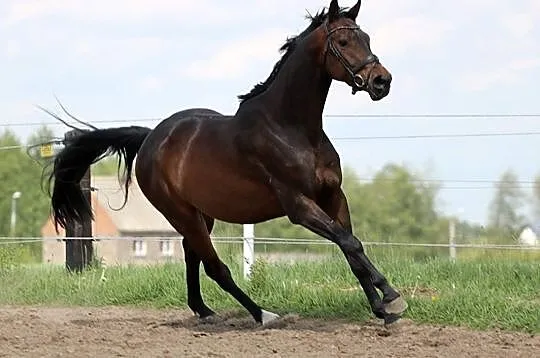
xmin=0 ymin=255 xmax=540 ymax=334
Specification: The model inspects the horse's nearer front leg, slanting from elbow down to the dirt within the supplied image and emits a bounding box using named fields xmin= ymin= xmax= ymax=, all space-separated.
xmin=273 ymin=182 xmax=400 ymax=324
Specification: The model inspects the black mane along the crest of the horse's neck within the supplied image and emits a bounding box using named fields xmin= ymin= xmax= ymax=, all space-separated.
xmin=238 ymin=8 xmax=347 ymax=103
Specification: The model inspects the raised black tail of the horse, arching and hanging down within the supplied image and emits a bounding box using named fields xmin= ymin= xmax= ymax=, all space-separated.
xmin=49 ymin=126 xmax=152 ymax=232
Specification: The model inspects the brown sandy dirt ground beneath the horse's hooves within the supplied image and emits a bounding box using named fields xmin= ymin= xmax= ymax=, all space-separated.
xmin=0 ymin=307 xmax=540 ymax=358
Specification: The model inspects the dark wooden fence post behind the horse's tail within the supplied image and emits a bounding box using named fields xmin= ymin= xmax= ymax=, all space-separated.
xmin=64 ymin=130 xmax=94 ymax=272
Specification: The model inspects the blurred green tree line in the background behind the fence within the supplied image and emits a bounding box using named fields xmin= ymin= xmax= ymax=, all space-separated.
xmin=0 ymin=126 xmax=540 ymax=262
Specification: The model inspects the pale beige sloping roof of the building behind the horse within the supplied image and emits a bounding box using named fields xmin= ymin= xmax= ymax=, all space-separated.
xmin=91 ymin=176 xmax=178 ymax=235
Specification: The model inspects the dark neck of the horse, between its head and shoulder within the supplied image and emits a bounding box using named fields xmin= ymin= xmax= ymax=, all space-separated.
xmin=264 ymin=42 xmax=332 ymax=141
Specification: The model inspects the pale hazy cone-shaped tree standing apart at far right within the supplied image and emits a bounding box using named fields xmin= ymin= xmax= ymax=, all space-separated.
xmin=488 ymin=169 xmax=525 ymax=232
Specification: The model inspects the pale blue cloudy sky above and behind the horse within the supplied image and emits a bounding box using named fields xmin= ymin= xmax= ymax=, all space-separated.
xmin=0 ymin=0 xmax=540 ymax=222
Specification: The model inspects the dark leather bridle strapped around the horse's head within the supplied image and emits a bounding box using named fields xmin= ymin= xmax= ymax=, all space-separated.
xmin=324 ymin=21 xmax=379 ymax=94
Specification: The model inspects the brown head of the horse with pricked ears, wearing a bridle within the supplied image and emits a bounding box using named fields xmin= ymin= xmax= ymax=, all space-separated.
xmin=321 ymin=0 xmax=392 ymax=101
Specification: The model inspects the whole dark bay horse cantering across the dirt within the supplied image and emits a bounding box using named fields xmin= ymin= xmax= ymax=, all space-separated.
xmin=48 ymin=0 xmax=407 ymax=325
